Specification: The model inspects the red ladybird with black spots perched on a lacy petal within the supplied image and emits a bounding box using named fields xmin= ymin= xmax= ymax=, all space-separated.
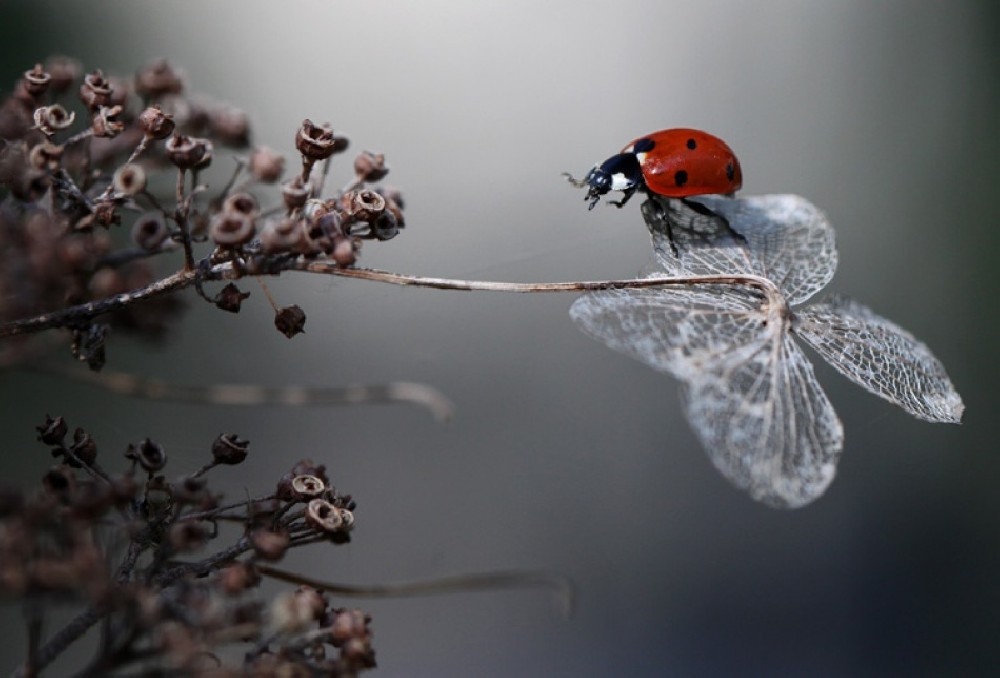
xmin=566 ymin=128 xmax=743 ymax=209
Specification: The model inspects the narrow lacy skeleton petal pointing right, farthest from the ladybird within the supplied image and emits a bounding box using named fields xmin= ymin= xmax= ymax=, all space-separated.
xmin=792 ymin=296 xmax=965 ymax=423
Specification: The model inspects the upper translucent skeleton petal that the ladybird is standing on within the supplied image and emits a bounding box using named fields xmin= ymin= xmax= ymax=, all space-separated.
xmin=642 ymin=195 xmax=837 ymax=304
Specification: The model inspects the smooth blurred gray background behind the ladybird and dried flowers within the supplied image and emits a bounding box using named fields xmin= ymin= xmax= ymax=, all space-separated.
xmin=0 ymin=0 xmax=1000 ymax=676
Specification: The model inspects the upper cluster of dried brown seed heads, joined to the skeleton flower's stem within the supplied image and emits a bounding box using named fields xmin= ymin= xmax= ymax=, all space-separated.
xmin=0 ymin=57 xmax=405 ymax=369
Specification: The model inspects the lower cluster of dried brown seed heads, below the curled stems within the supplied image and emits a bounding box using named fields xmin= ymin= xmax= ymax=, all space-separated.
xmin=0 ymin=417 xmax=375 ymax=676
